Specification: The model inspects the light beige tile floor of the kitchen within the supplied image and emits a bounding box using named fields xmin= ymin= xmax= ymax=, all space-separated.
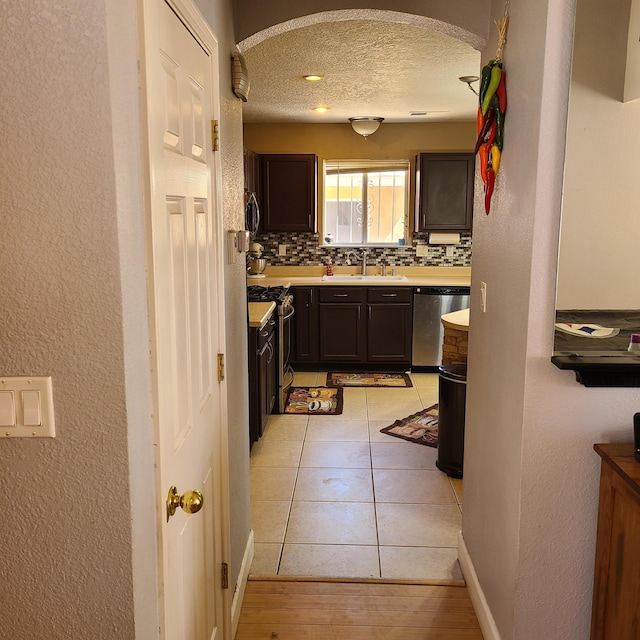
xmin=251 ymin=372 xmax=462 ymax=580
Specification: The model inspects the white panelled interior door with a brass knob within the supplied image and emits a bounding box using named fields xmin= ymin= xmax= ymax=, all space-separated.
xmin=144 ymin=0 xmax=226 ymax=640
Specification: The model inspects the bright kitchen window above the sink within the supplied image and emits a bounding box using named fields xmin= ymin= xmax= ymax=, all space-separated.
xmin=324 ymin=160 xmax=410 ymax=246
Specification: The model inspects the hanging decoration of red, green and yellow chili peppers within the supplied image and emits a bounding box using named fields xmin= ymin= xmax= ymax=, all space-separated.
xmin=475 ymin=5 xmax=509 ymax=215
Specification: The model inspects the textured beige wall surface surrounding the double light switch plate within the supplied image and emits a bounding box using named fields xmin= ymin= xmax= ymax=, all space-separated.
xmin=0 ymin=0 xmax=134 ymax=640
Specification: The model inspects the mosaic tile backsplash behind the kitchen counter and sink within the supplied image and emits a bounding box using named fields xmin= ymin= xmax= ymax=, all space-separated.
xmin=255 ymin=233 xmax=471 ymax=267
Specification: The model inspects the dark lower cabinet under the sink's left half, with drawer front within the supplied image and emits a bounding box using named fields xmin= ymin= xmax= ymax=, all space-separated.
xmin=319 ymin=287 xmax=366 ymax=362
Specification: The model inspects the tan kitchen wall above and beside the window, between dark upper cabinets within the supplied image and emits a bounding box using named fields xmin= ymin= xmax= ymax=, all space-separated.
xmin=244 ymin=122 xmax=476 ymax=231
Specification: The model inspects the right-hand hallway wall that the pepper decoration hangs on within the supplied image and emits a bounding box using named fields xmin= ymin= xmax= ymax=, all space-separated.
xmin=463 ymin=0 xmax=638 ymax=640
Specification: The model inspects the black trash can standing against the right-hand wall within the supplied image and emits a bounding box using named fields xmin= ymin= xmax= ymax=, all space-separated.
xmin=436 ymin=364 xmax=467 ymax=478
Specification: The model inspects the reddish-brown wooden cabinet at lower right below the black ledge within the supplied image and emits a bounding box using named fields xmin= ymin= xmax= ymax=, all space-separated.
xmin=591 ymin=444 xmax=640 ymax=640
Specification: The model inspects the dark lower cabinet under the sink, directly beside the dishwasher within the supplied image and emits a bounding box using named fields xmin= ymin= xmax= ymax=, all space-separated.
xmin=367 ymin=287 xmax=413 ymax=364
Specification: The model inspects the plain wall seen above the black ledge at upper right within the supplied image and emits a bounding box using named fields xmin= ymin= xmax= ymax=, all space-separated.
xmin=558 ymin=0 xmax=640 ymax=309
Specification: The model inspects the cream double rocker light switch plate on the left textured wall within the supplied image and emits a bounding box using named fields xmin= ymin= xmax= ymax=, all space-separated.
xmin=0 ymin=376 xmax=56 ymax=438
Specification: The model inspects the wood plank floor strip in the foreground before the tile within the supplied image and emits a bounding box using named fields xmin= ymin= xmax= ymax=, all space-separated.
xmin=236 ymin=579 xmax=482 ymax=640
